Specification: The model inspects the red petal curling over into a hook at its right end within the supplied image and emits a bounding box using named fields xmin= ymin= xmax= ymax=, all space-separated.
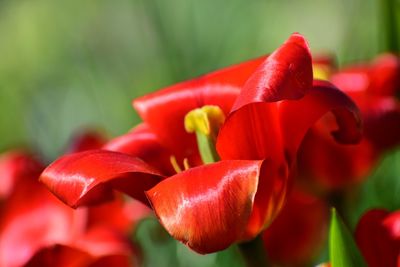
xmin=217 ymin=81 xmax=361 ymax=163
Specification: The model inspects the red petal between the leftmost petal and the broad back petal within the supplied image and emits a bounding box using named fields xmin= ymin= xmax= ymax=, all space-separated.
xmin=103 ymin=123 xmax=175 ymax=175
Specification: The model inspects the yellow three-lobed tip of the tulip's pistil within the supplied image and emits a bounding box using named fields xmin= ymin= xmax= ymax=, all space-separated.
xmin=185 ymin=105 xmax=225 ymax=138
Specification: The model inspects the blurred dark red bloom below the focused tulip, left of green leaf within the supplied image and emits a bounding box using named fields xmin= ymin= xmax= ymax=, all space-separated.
xmin=263 ymin=190 xmax=329 ymax=266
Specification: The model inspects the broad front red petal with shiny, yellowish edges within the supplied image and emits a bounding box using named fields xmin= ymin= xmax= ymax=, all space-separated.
xmin=146 ymin=161 xmax=262 ymax=253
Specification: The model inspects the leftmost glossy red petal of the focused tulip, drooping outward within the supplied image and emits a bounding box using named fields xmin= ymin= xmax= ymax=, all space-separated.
xmin=40 ymin=150 xmax=165 ymax=207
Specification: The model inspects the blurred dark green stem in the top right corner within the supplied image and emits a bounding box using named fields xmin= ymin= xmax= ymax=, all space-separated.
xmin=380 ymin=0 xmax=400 ymax=52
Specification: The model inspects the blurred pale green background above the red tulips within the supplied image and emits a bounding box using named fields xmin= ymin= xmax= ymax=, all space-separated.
xmin=0 ymin=0 xmax=396 ymax=160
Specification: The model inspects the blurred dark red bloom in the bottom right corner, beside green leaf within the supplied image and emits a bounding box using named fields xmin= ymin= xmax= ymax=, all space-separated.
xmin=355 ymin=209 xmax=400 ymax=267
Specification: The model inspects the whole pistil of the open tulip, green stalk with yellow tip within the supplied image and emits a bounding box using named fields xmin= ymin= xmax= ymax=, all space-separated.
xmin=185 ymin=105 xmax=225 ymax=164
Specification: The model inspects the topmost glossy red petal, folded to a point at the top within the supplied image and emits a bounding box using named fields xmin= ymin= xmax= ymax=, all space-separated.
xmin=232 ymin=33 xmax=313 ymax=111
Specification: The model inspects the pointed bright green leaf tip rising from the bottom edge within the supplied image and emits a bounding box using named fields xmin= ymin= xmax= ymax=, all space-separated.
xmin=329 ymin=208 xmax=366 ymax=267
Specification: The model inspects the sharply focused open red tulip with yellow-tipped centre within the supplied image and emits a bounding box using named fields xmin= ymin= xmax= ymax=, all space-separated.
xmin=40 ymin=34 xmax=360 ymax=253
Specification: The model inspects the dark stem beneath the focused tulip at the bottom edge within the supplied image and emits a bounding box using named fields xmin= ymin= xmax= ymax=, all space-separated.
xmin=239 ymin=235 xmax=268 ymax=267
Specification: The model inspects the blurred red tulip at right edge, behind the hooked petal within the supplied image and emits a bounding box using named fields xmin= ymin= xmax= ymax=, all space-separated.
xmin=299 ymin=55 xmax=400 ymax=190
